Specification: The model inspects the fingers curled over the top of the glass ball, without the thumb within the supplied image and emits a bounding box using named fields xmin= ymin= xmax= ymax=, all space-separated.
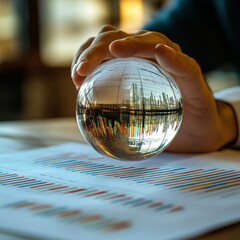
xmin=71 ymin=25 xmax=181 ymax=88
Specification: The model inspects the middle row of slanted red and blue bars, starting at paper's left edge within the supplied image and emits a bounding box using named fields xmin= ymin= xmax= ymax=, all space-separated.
xmin=0 ymin=172 xmax=183 ymax=211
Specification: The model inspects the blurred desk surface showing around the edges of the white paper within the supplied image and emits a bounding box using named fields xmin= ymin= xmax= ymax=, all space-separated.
xmin=0 ymin=118 xmax=240 ymax=240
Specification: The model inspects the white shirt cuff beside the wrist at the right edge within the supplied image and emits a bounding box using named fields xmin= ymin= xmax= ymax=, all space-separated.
xmin=214 ymin=86 xmax=240 ymax=149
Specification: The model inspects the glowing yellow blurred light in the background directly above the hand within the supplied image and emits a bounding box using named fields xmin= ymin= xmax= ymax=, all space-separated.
xmin=120 ymin=0 xmax=144 ymax=32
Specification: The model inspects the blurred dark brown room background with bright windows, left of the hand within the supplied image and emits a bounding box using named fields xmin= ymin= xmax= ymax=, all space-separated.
xmin=0 ymin=0 xmax=239 ymax=121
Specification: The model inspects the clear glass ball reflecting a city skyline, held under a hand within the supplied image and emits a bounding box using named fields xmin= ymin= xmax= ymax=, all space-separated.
xmin=76 ymin=58 xmax=182 ymax=161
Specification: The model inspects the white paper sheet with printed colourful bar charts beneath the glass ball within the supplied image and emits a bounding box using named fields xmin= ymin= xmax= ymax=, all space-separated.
xmin=0 ymin=143 xmax=240 ymax=240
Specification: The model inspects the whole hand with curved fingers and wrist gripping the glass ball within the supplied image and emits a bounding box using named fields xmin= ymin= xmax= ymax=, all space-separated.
xmin=72 ymin=26 xmax=237 ymax=152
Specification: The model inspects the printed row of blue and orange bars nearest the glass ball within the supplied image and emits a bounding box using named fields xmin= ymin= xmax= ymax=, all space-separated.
xmin=35 ymin=155 xmax=240 ymax=193
